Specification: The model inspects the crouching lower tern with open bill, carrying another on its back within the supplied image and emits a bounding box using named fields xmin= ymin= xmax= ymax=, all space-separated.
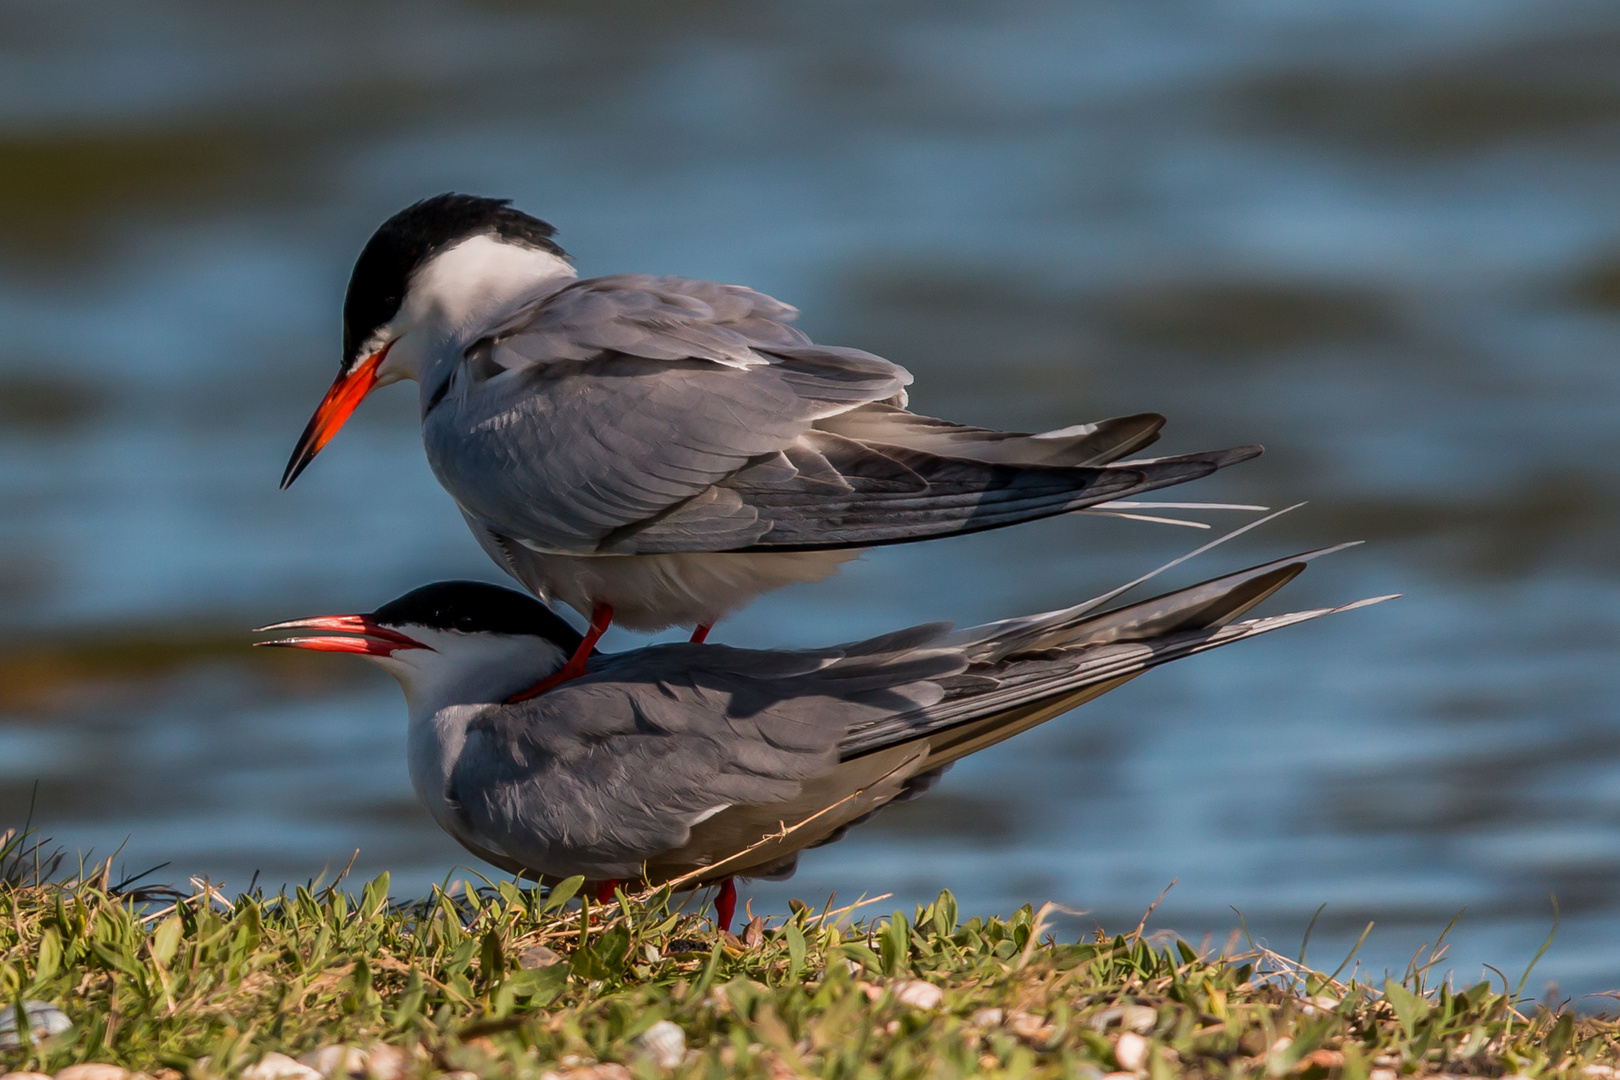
xmin=258 ymin=547 xmax=1392 ymax=929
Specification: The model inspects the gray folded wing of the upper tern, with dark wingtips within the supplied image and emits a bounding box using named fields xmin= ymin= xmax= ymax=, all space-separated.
xmin=423 ymin=277 xmax=1259 ymax=555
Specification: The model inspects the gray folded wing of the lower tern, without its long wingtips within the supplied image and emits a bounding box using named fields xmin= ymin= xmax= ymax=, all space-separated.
xmin=450 ymin=625 xmax=964 ymax=879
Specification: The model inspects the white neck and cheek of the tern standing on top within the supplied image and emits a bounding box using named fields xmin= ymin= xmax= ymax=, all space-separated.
xmin=387 ymin=236 xmax=577 ymax=387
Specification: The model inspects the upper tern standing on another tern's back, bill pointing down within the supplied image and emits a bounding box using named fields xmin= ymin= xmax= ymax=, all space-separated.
xmin=282 ymin=194 xmax=1260 ymax=693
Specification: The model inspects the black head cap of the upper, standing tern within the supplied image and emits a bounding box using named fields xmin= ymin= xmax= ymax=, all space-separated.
xmin=343 ymin=191 xmax=567 ymax=371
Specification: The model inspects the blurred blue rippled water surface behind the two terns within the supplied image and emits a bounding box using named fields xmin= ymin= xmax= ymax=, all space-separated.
xmin=0 ymin=0 xmax=1620 ymax=993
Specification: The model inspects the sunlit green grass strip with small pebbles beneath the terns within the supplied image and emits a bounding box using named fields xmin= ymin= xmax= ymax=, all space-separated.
xmin=0 ymin=839 xmax=1617 ymax=1080
